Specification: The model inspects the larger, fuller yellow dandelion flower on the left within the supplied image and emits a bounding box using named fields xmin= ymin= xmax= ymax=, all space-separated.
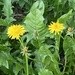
xmin=7 ymin=25 xmax=25 ymax=39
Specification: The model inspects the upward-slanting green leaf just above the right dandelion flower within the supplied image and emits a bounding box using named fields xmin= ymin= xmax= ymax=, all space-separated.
xmin=57 ymin=9 xmax=73 ymax=23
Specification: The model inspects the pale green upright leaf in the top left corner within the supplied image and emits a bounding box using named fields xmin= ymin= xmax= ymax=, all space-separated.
xmin=3 ymin=0 xmax=15 ymax=26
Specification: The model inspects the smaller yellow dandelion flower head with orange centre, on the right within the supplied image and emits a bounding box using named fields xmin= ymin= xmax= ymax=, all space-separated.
xmin=49 ymin=22 xmax=65 ymax=35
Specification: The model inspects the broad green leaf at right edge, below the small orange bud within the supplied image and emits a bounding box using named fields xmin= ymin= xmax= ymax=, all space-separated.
xmin=63 ymin=36 xmax=75 ymax=55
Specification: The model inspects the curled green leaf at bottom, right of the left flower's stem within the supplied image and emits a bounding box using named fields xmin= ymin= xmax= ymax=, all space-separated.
xmin=39 ymin=45 xmax=61 ymax=75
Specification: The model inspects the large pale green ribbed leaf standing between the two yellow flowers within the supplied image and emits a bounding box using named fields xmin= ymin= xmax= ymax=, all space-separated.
xmin=24 ymin=1 xmax=47 ymax=41
